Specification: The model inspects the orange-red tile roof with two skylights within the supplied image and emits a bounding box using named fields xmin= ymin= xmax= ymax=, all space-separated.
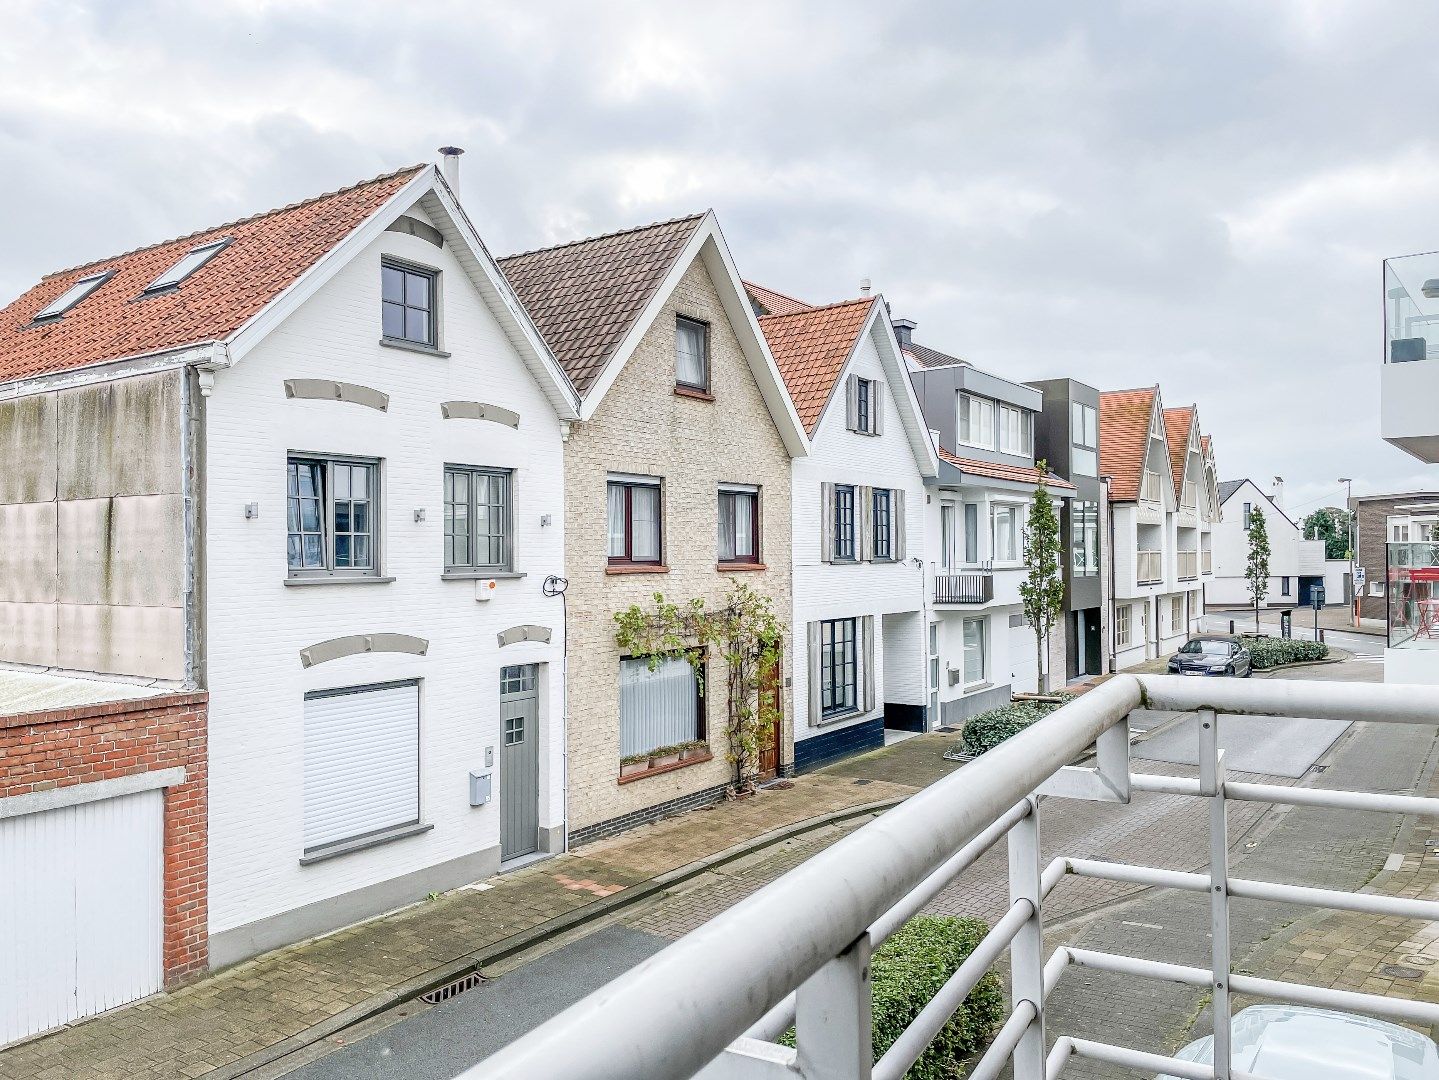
xmin=0 ymin=165 xmax=427 ymax=383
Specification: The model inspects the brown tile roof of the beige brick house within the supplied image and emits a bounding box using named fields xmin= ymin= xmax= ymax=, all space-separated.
xmin=499 ymin=214 xmax=705 ymax=395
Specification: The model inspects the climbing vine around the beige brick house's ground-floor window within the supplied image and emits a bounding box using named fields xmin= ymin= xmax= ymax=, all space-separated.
xmin=614 ymin=581 xmax=784 ymax=795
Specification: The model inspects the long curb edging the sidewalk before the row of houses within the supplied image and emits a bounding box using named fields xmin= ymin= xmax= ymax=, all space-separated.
xmin=203 ymin=795 xmax=908 ymax=1080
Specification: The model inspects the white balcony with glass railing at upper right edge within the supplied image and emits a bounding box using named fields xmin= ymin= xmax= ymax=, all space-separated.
xmin=1379 ymin=252 xmax=1439 ymax=465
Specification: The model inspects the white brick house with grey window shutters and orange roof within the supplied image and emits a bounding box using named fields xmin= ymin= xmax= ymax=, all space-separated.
xmin=751 ymin=289 xmax=938 ymax=771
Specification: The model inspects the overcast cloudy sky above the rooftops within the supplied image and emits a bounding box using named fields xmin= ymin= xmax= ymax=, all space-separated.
xmin=0 ymin=0 xmax=1439 ymax=515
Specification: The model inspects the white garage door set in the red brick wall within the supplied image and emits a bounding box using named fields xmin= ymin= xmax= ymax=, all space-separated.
xmin=0 ymin=791 xmax=164 ymax=1045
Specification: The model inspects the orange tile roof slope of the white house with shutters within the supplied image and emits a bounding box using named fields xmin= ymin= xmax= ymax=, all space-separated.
xmin=760 ymin=296 xmax=875 ymax=434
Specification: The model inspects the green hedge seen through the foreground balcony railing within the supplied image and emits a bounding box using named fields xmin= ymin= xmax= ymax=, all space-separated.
xmin=781 ymin=915 xmax=1004 ymax=1080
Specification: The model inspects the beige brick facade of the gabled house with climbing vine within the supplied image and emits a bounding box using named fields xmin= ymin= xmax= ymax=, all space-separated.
xmin=564 ymin=259 xmax=793 ymax=833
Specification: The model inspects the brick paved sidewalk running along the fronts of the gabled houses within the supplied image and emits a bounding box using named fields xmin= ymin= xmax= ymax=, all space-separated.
xmin=0 ymin=753 xmax=932 ymax=1080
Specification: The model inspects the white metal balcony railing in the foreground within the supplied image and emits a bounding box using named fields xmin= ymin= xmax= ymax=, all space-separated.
xmin=477 ymin=674 xmax=1439 ymax=1080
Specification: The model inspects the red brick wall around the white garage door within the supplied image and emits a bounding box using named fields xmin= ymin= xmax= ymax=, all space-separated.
xmin=0 ymin=693 xmax=209 ymax=984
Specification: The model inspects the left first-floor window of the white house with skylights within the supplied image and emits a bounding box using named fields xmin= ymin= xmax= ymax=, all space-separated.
xmin=286 ymin=456 xmax=380 ymax=577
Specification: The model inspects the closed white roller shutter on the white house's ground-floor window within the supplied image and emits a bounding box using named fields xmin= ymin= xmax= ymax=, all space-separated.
xmin=305 ymin=683 xmax=420 ymax=854
